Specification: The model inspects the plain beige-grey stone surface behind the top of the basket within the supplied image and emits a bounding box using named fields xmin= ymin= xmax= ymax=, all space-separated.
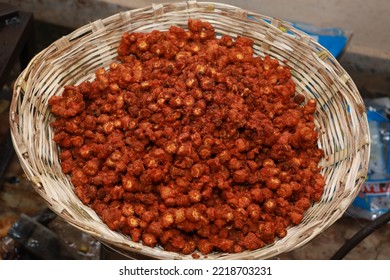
xmin=3 ymin=0 xmax=390 ymax=59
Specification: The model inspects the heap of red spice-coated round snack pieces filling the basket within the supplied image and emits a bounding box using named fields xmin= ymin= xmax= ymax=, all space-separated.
xmin=49 ymin=19 xmax=325 ymax=255
